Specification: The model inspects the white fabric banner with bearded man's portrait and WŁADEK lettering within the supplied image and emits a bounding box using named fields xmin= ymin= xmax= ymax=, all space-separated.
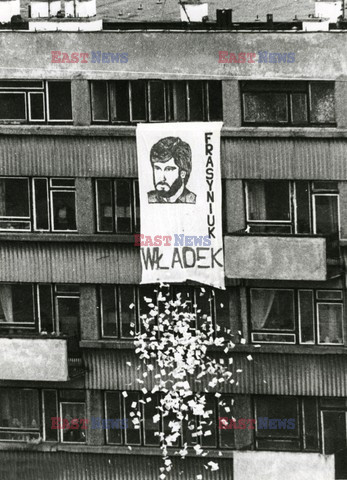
xmin=135 ymin=122 xmax=225 ymax=288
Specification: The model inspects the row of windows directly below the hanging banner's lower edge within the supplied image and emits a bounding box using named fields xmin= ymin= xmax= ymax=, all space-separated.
xmin=0 ymin=284 xmax=344 ymax=350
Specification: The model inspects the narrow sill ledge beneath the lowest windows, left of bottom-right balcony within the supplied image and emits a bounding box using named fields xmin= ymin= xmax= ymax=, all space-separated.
xmin=0 ymin=442 xmax=237 ymax=458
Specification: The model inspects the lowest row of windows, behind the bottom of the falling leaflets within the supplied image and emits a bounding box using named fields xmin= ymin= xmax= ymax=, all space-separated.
xmin=0 ymin=388 xmax=347 ymax=454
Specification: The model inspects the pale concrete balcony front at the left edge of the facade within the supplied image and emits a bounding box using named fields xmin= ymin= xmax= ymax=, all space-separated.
xmin=0 ymin=338 xmax=68 ymax=382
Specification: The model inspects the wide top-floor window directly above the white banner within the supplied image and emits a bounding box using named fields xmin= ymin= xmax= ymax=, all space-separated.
xmin=91 ymin=80 xmax=223 ymax=123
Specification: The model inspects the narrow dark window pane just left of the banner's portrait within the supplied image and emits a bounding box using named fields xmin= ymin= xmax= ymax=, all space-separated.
xmin=115 ymin=179 xmax=132 ymax=233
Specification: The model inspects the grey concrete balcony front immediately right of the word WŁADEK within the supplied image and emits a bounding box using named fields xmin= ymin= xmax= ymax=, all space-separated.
xmin=224 ymin=235 xmax=328 ymax=281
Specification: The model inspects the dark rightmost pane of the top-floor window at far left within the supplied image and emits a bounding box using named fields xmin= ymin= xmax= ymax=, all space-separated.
xmin=48 ymin=82 xmax=72 ymax=120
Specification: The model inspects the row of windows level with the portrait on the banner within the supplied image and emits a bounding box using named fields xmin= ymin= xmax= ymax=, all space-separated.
xmin=0 ymin=177 xmax=339 ymax=240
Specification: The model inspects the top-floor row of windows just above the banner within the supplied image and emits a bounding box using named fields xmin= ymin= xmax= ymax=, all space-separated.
xmin=0 ymin=80 xmax=336 ymax=126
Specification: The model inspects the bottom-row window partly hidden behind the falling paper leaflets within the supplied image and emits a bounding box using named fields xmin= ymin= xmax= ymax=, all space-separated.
xmin=105 ymin=391 xmax=228 ymax=448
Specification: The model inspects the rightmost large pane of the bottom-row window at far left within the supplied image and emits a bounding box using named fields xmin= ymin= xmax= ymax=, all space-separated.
xmin=61 ymin=402 xmax=86 ymax=443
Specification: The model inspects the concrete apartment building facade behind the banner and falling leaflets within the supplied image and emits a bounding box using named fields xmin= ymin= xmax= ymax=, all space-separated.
xmin=0 ymin=0 xmax=347 ymax=480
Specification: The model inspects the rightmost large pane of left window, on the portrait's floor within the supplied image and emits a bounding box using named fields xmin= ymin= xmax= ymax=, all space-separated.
xmin=52 ymin=191 xmax=76 ymax=230
